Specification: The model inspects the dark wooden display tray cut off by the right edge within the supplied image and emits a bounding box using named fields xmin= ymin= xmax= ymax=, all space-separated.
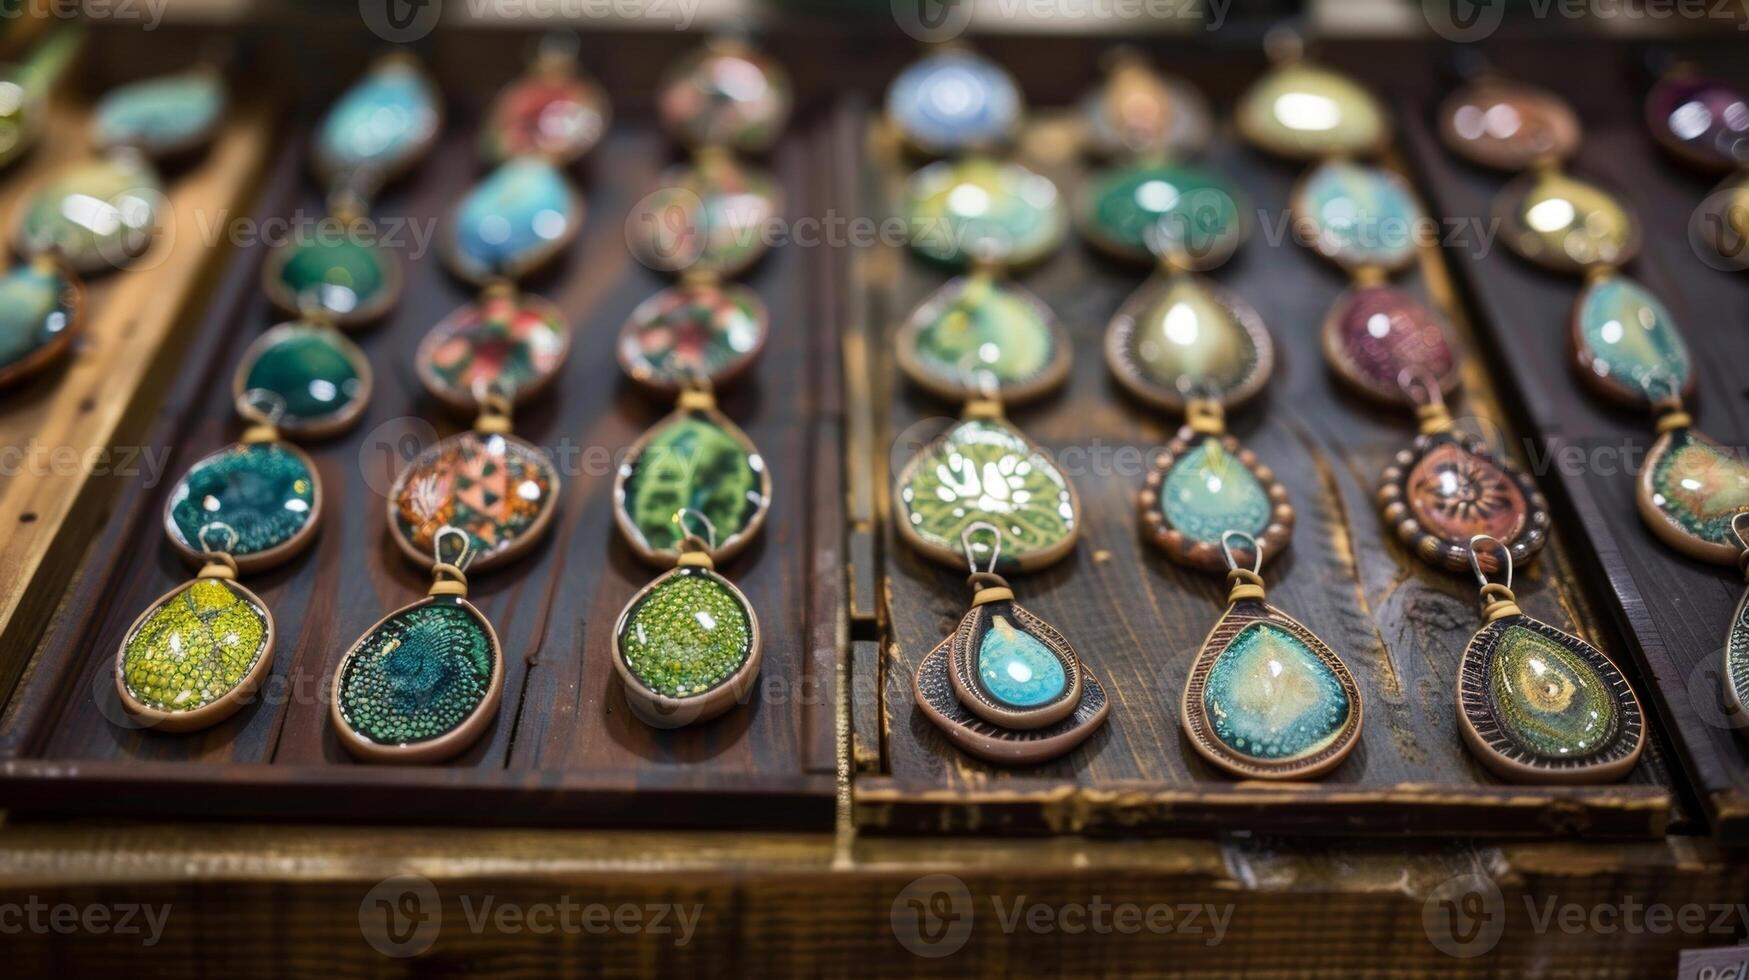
xmin=1403 ymin=32 xmax=1749 ymax=844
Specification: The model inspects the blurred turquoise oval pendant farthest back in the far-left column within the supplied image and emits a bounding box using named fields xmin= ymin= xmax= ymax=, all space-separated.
xmin=91 ymin=68 xmax=226 ymax=159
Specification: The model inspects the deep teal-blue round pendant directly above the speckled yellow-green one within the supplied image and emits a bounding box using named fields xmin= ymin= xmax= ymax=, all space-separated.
xmin=164 ymin=443 xmax=322 ymax=574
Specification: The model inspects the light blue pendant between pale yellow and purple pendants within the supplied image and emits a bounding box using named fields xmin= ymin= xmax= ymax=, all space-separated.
xmin=1293 ymin=159 xmax=1427 ymax=271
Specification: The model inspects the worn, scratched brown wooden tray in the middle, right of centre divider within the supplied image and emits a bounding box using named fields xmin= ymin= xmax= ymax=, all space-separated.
xmin=847 ymin=49 xmax=1672 ymax=837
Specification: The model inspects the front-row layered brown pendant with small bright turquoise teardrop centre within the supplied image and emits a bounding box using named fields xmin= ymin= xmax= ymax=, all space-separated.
xmin=911 ymin=522 xmax=1111 ymax=765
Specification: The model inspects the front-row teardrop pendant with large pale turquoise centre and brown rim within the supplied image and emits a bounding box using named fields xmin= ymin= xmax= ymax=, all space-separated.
xmin=1179 ymin=530 xmax=1362 ymax=779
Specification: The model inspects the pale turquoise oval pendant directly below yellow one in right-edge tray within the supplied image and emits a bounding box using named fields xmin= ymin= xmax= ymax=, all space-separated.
xmin=1569 ymin=275 xmax=1695 ymax=406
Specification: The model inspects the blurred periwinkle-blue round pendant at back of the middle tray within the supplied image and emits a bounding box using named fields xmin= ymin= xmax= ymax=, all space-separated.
xmin=887 ymin=47 xmax=1023 ymax=156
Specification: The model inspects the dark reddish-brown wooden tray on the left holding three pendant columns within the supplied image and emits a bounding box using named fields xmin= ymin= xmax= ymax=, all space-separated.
xmin=0 ymin=90 xmax=843 ymax=828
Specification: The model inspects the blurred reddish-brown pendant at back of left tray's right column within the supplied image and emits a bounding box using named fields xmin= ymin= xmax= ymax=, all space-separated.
xmin=656 ymin=40 xmax=791 ymax=152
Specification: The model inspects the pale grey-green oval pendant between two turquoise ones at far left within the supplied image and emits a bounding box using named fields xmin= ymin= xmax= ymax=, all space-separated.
xmin=16 ymin=152 xmax=164 ymax=275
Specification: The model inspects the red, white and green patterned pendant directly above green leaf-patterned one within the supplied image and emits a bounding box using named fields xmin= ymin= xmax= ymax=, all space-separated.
xmin=617 ymin=282 xmax=766 ymax=394
